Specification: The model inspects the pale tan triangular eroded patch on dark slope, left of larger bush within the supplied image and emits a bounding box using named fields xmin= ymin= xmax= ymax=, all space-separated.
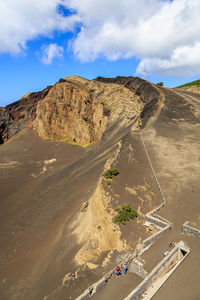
xmin=72 ymin=179 xmax=128 ymax=265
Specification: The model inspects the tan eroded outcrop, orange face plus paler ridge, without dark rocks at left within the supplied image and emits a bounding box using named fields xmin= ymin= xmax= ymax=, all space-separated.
xmin=33 ymin=76 xmax=157 ymax=143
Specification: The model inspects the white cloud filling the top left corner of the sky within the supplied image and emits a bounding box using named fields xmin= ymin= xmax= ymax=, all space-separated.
xmin=0 ymin=0 xmax=79 ymax=54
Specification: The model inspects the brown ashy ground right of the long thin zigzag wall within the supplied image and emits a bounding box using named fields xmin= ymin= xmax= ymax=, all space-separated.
xmin=92 ymin=85 xmax=200 ymax=300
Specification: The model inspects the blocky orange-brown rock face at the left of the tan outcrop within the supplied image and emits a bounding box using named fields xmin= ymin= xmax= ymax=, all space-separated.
xmin=33 ymin=80 xmax=108 ymax=143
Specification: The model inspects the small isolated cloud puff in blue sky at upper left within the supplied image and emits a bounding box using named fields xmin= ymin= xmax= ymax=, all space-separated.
xmin=41 ymin=44 xmax=64 ymax=65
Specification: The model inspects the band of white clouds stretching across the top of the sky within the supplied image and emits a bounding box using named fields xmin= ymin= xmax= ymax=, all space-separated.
xmin=0 ymin=0 xmax=200 ymax=76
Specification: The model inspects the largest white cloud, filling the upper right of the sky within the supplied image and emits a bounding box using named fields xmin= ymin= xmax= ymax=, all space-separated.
xmin=66 ymin=0 xmax=200 ymax=76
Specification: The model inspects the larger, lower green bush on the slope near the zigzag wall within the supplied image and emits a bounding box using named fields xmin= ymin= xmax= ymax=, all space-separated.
xmin=114 ymin=204 xmax=138 ymax=225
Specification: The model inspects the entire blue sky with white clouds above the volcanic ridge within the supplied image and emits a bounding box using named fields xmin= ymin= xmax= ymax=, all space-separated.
xmin=0 ymin=0 xmax=200 ymax=106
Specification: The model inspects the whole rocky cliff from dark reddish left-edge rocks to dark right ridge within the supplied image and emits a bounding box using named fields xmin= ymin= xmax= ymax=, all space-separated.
xmin=0 ymin=76 xmax=162 ymax=144
